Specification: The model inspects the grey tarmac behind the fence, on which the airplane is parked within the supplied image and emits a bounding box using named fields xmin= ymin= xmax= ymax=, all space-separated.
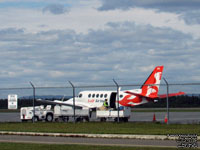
xmin=0 ymin=112 xmax=200 ymax=124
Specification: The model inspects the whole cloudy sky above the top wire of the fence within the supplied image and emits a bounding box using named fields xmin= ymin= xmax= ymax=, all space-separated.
xmin=0 ymin=0 xmax=200 ymax=88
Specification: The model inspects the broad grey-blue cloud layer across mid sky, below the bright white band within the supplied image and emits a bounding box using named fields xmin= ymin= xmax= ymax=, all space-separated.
xmin=0 ymin=22 xmax=200 ymax=90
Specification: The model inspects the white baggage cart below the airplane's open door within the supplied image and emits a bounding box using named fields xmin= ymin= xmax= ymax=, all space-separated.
xmin=96 ymin=107 xmax=131 ymax=122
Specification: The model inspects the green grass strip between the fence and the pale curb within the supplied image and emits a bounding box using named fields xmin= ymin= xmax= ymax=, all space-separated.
xmin=0 ymin=122 xmax=200 ymax=135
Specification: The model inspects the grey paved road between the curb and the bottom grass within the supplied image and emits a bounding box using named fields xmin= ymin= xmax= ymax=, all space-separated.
xmin=0 ymin=135 xmax=180 ymax=147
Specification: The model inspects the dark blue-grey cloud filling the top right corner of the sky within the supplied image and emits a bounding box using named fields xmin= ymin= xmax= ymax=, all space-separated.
xmin=98 ymin=0 xmax=200 ymax=24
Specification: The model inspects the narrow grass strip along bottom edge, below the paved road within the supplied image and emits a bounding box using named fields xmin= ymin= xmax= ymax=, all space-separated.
xmin=0 ymin=143 xmax=177 ymax=150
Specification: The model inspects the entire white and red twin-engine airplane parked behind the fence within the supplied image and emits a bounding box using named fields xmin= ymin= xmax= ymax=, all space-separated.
xmin=37 ymin=66 xmax=185 ymax=109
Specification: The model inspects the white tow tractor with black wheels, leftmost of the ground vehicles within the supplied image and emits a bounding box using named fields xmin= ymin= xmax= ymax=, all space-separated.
xmin=20 ymin=105 xmax=54 ymax=122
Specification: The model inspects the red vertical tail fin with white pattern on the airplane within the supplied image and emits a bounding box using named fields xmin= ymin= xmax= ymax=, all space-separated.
xmin=141 ymin=66 xmax=164 ymax=98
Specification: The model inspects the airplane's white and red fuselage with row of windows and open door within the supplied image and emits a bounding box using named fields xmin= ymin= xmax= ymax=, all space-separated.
xmin=63 ymin=89 xmax=148 ymax=108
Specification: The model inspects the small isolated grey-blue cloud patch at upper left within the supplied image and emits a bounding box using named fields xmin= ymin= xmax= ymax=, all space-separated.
xmin=43 ymin=4 xmax=69 ymax=15
